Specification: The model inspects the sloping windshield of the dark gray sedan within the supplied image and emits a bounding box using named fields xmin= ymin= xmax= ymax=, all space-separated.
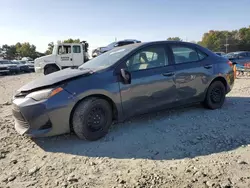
xmin=79 ymin=44 xmax=139 ymax=70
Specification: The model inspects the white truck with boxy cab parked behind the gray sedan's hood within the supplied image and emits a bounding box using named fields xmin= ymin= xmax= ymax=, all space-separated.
xmin=34 ymin=41 xmax=89 ymax=75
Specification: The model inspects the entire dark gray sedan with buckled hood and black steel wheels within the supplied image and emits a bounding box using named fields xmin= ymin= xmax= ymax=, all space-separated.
xmin=13 ymin=41 xmax=234 ymax=140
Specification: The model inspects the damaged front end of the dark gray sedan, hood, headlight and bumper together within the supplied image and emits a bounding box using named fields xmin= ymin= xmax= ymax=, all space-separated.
xmin=12 ymin=69 xmax=92 ymax=137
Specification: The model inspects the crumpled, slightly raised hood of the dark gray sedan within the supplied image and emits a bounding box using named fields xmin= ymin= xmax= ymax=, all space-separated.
xmin=18 ymin=68 xmax=93 ymax=92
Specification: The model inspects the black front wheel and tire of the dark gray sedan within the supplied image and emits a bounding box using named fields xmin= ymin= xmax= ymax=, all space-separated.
xmin=72 ymin=97 xmax=112 ymax=141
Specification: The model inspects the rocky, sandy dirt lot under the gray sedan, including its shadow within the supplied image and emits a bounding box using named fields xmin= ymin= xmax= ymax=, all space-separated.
xmin=0 ymin=74 xmax=250 ymax=188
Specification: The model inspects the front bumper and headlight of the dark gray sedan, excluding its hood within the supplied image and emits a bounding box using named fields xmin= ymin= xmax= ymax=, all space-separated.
xmin=12 ymin=87 xmax=73 ymax=137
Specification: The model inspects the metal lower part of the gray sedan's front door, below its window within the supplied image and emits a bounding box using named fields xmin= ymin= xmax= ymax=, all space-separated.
xmin=120 ymin=65 xmax=176 ymax=116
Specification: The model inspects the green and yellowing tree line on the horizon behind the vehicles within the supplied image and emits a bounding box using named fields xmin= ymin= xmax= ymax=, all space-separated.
xmin=0 ymin=26 xmax=250 ymax=59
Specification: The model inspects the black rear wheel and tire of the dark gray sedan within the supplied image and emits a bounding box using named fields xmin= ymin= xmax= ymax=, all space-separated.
xmin=203 ymin=81 xmax=226 ymax=110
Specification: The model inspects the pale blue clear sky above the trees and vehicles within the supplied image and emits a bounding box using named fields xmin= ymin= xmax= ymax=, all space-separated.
xmin=0 ymin=0 xmax=250 ymax=52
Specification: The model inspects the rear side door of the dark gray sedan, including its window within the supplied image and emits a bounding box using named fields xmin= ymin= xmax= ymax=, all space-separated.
xmin=171 ymin=45 xmax=210 ymax=103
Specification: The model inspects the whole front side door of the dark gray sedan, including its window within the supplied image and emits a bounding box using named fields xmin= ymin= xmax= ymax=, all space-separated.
xmin=120 ymin=45 xmax=176 ymax=116
